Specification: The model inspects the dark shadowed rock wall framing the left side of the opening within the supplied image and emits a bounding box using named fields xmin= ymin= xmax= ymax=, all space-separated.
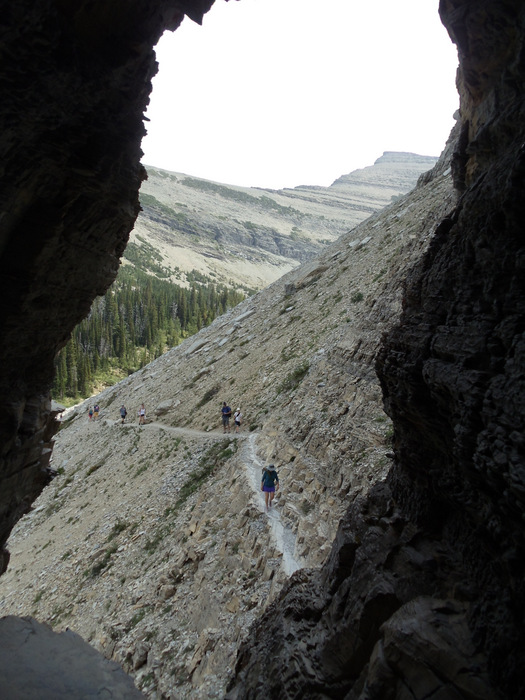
xmin=0 ymin=0 xmax=213 ymax=573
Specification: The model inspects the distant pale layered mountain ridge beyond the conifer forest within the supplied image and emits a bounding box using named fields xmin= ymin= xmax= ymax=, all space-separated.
xmin=132 ymin=152 xmax=437 ymax=290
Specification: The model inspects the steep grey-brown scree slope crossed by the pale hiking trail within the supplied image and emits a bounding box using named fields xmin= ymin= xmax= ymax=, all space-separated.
xmin=0 ymin=149 xmax=454 ymax=698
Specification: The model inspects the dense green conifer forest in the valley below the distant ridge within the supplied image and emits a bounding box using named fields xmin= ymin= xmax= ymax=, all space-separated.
xmin=52 ymin=265 xmax=244 ymax=403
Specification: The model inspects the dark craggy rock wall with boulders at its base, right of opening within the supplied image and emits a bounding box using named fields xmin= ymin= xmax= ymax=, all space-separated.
xmin=228 ymin=0 xmax=525 ymax=700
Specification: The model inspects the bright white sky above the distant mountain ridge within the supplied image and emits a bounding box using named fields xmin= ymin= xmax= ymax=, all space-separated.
xmin=142 ymin=0 xmax=459 ymax=189
